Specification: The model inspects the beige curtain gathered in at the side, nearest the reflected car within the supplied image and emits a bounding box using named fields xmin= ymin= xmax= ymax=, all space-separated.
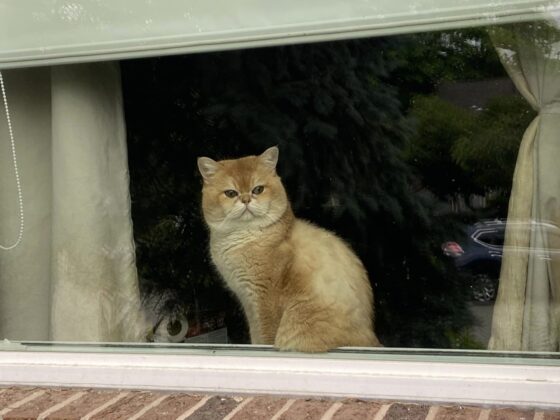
xmin=488 ymin=22 xmax=560 ymax=351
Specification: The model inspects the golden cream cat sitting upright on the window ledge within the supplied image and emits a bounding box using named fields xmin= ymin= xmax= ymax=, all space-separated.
xmin=198 ymin=147 xmax=381 ymax=352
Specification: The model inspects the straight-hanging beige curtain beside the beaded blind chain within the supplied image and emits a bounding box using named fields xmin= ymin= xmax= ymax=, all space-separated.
xmin=0 ymin=63 xmax=145 ymax=341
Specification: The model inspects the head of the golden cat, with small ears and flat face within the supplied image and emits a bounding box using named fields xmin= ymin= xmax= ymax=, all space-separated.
xmin=198 ymin=147 xmax=288 ymax=232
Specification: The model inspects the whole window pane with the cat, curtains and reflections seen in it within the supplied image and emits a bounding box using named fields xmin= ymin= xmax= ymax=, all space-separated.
xmin=0 ymin=21 xmax=560 ymax=352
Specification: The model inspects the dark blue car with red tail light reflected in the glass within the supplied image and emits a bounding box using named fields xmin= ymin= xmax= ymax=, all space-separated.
xmin=442 ymin=219 xmax=560 ymax=302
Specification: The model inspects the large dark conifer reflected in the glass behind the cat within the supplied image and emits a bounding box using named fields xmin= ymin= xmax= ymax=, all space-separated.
xmin=123 ymin=39 xmax=470 ymax=347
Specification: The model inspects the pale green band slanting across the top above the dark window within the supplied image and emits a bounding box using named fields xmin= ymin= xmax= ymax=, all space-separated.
xmin=0 ymin=0 xmax=560 ymax=68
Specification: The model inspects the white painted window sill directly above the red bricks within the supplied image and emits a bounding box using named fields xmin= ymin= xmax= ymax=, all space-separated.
xmin=0 ymin=351 xmax=560 ymax=408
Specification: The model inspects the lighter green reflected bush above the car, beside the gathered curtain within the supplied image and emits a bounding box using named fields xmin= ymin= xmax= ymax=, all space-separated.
xmin=406 ymin=95 xmax=535 ymax=217
